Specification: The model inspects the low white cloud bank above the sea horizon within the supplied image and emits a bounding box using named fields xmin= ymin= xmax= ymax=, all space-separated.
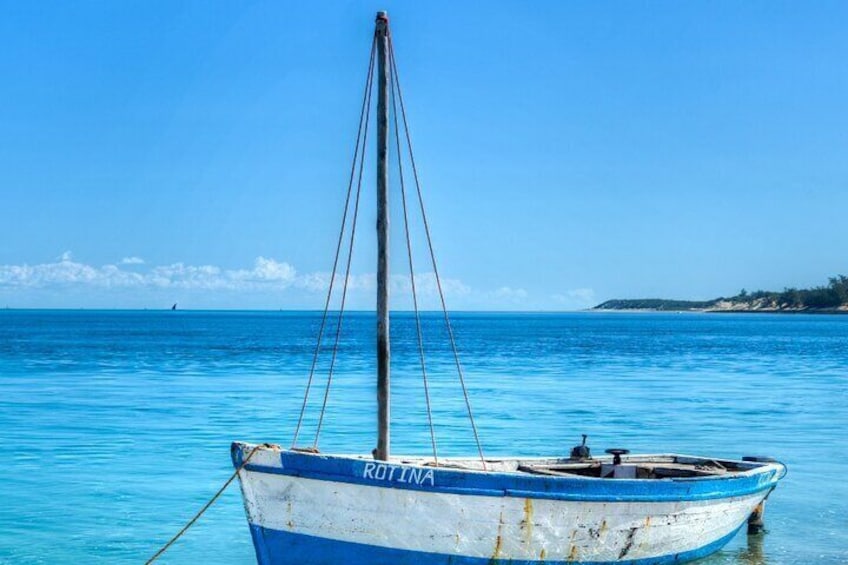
xmin=0 ymin=251 xmax=595 ymax=310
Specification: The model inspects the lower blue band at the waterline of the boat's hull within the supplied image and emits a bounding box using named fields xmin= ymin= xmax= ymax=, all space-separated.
xmin=243 ymin=524 xmax=739 ymax=565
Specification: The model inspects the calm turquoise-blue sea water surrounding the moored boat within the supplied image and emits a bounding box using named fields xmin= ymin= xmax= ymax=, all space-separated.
xmin=0 ymin=310 xmax=848 ymax=565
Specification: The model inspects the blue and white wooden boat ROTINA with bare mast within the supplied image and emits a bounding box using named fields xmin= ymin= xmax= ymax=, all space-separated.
xmin=232 ymin=12 xmax=785 ymax=565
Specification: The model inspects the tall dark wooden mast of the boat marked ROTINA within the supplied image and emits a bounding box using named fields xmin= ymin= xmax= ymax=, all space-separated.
xmin=374 ymin=12 xmax=391 ymax=461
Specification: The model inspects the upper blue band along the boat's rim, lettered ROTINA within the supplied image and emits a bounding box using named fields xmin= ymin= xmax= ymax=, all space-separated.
xmin=232 ymin=444 xmax=780 ymax=502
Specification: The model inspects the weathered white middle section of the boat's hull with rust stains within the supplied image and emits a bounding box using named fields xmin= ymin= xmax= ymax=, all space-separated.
xmin=230 ymin=442 xmax=770 ymax=563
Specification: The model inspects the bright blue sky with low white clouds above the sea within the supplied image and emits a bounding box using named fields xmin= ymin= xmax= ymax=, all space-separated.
xmin=0 ymin=0 xmax=848 ymax=310
